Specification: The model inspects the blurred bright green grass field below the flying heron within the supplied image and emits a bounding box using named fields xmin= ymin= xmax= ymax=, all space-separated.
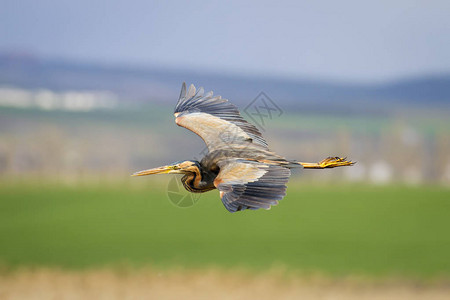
xmin=0 ymin=180 xmax=450 ymax=279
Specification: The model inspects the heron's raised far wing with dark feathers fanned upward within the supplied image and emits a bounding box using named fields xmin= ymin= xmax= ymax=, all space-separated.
xmin=174 ymin=83 xmax=267 ymax=152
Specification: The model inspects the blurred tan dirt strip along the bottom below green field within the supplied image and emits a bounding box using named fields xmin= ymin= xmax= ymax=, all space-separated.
xmin=0 ymin=269 xmax=450 ymax=300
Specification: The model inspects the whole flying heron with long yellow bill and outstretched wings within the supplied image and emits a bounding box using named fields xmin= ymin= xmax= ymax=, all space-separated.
xmin=132 ymin=83 xmax=354 ymax=212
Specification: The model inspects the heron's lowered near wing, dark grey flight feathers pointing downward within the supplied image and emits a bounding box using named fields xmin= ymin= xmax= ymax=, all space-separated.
xmin=214 ymin=159 xmax=291 ymax=212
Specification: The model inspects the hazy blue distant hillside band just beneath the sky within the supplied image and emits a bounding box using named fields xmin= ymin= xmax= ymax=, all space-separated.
xmin=0 ymin=55 xmax=450 ymax=111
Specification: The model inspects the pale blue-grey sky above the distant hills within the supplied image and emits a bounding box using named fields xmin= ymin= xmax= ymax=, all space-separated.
xmin=0 ymin=0 xmax=450 ymax=82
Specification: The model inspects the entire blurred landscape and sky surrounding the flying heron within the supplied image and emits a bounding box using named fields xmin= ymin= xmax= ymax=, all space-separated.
xmin=0 ymin=0 xmax=450 ymax=299
